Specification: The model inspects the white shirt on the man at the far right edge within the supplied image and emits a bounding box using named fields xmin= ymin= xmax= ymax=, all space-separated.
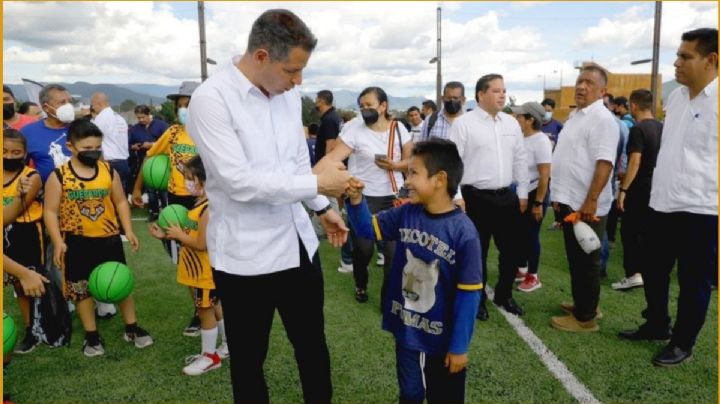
xmin=650 ymin=77 xmax=718 ymax=216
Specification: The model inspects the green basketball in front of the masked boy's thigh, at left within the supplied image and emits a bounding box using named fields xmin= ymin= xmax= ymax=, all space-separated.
xmin=88 ymin=261 xmax=135 ymax=303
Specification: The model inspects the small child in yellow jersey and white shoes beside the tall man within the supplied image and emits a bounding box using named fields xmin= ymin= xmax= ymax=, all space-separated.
xmin=150 ymin=156 xmax=228 ymax=376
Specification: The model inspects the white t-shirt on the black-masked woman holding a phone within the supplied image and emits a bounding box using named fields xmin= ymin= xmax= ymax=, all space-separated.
xmin=340 ymin=118 xmax=412 ymax=196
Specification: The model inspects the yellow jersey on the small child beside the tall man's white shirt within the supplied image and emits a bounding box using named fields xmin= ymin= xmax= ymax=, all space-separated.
xmin=177 ymin=201 xmax=215 ymax=289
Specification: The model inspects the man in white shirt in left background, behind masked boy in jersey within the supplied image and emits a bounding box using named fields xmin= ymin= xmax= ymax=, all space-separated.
xmin=90 ymin=92 xmax=130 ymax=193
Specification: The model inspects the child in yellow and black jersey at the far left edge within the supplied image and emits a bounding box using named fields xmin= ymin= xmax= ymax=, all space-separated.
xmin=3 ymin=129 xmax=45 ymax=354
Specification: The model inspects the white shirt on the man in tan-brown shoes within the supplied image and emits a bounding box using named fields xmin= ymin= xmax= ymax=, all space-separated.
xmin=550 ymin=99 xmax=620 ymax=216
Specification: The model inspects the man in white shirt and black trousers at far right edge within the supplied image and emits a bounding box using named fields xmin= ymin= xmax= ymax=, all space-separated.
xmin=620 ymin=28 xmax=718 ymax=366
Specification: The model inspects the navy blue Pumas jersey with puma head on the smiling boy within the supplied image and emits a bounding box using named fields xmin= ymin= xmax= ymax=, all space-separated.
xmin=362 ymin=204 xmax=483 ymax=354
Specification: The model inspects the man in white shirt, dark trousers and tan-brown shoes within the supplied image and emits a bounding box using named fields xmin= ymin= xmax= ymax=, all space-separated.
xmin=550 ymin=65 xmax=619 ymax=332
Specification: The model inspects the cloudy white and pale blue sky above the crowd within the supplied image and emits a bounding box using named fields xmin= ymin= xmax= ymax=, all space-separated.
xmin=3 ymin=1 xmax=718 ymax=102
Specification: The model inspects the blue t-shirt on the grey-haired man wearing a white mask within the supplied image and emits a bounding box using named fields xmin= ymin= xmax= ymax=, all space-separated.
xmin=20 ymin=119 xmax=72 ymax=182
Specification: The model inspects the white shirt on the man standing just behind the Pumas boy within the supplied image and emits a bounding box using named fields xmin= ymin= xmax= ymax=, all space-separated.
xmin=449 ymin=107 xmax=528 ymax=199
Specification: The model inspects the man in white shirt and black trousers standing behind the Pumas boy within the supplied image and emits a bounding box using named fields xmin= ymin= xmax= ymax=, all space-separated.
xmin=449 ymin=74 xmax=528 ymax=321
